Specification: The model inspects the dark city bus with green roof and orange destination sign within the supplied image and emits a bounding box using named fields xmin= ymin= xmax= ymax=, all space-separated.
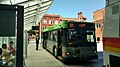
xmin=42 ymin=21 xmax=98 ymax=62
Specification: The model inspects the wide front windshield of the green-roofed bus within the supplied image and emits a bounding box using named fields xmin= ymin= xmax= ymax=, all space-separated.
xmin=67 ymin=29 xmax=94 ymax=44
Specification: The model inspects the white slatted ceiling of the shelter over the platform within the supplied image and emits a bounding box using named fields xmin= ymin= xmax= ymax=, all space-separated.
xmin=0 ymin=0 xmax=54 ymax=30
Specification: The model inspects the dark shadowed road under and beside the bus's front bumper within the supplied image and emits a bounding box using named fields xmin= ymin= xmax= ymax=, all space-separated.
xmin=61 ymin=52 xmax=103 ymax=67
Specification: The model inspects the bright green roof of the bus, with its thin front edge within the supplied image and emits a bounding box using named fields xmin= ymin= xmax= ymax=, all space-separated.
xmin=42 ymin=21 xmax=94 ymax=32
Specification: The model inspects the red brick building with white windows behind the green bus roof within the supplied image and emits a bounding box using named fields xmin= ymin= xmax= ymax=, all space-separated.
xmin=40 ymin=12 xmax=87 ymax=30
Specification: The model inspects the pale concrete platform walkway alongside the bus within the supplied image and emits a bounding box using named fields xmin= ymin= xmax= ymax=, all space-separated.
xmin=25 ymin=42 xmax=64 ymax=67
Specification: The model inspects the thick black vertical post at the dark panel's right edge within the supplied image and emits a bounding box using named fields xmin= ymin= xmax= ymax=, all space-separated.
xmin=16 ymin=6 xmax=24 ymax=67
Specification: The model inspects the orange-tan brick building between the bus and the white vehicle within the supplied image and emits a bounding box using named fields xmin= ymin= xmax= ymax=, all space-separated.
xmin=93 ymin=8 xmax=105 ymax=41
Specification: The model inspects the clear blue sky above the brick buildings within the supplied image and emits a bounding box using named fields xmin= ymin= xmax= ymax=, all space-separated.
xmin=46 ymin=0 xmax=105 ymax=21
